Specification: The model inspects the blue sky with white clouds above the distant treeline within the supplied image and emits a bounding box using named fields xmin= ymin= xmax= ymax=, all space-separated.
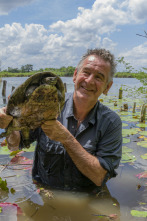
xmin=0 ymin=0 xmax=147 ymax=71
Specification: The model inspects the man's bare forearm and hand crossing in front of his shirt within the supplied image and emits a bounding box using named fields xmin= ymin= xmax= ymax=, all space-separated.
xmin=42 ymin=120 xmax=107 ymax=186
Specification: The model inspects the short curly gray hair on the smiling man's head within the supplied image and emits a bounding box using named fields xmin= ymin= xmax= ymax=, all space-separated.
xmin=77 ymin=48 xmax=116 ymax=82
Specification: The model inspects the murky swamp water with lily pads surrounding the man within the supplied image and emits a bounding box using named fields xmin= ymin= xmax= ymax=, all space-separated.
xmin=0 ymin=77 xmax=147 ymax=221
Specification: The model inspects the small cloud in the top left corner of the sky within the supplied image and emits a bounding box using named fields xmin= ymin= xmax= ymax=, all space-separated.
xmin=0 ymin=0 xmax=34 ymax=15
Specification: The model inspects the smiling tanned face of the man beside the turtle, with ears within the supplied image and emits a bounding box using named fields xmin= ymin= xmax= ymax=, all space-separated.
xmin=73 ymin=55 xmax=113 ymax=104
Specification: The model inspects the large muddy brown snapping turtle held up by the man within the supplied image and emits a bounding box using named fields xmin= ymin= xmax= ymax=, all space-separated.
xmin=0 ymin=72 xmax=65 ymax=148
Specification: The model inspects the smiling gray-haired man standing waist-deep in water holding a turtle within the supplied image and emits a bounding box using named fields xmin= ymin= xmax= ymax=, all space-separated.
xmin=0 ymin=49 xmax=122 ymax=191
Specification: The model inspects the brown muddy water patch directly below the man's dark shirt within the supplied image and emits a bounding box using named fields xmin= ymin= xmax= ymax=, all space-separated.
xmin=21 ymin=188 xmax=120 ymax=221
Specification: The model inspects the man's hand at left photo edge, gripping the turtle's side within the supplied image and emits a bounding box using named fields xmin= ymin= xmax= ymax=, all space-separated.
xmin=0 ymin=107 xmax=13 ymax=129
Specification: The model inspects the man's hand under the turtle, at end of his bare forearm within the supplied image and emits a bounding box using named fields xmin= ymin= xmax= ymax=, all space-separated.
xmin=41 ymin=120 xmax=69 ymax=144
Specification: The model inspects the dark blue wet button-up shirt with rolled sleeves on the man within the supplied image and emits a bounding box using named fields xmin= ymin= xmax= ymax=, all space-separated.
xmin=20 ymin=94 xmax=122 ymax=190
